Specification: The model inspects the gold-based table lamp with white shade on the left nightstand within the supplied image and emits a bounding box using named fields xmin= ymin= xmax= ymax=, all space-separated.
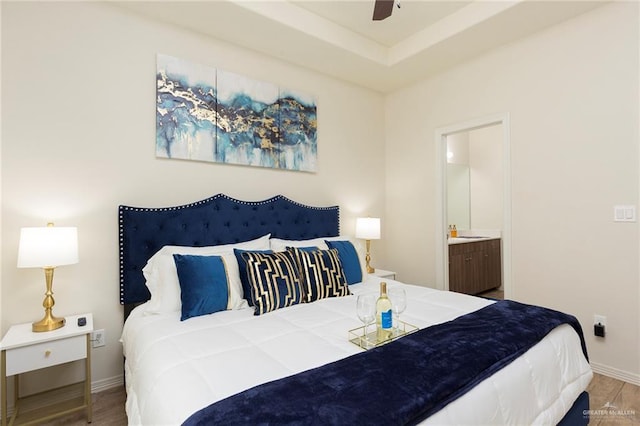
xmin=18 ymin=223 xmax=78 ymax=332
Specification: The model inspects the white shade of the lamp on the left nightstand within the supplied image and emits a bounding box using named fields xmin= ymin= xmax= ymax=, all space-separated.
xmin=18 ymin=226 xmax=78 ymax=268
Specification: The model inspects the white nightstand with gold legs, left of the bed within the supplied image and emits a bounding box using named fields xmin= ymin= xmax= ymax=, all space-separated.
xmin=0 ymin=314 xmax=93 ymax=426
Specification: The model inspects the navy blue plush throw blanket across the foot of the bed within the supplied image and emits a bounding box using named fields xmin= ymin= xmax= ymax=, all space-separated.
xmin=184 ymin=300 xmax=587 ymax=426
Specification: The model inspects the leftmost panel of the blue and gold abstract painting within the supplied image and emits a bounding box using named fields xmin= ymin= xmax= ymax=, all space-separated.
xmin=156 ymin=55 xmax=217 ymax=161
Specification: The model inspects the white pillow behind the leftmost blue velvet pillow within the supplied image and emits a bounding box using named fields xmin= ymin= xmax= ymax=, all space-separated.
xmin=142 ymin=234 xmax=270 ymax=314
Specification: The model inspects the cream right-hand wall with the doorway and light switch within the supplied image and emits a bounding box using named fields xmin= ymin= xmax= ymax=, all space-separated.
xmin=385 ymin=2 xmax=640 ymax=383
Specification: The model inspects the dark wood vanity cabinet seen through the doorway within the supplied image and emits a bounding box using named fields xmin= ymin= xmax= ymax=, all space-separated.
xmin=449 ymin=239 xmax=502 ymax=294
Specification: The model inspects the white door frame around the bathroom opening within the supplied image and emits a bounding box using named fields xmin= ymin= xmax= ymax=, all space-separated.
xmin=435 ymin=114 xmax=512 ymax=298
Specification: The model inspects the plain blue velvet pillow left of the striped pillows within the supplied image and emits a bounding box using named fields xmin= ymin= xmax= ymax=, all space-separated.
xmin=173 ymin=254 xmax=229 ymax=321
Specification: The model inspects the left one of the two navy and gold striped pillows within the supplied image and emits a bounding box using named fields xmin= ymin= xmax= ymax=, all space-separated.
xmin=242 ymin=251 xmax=304 ymax=315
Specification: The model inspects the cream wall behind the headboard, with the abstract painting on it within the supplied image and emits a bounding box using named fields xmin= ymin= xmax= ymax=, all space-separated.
xmin=1 ymin=2 xmax=384 ymax=392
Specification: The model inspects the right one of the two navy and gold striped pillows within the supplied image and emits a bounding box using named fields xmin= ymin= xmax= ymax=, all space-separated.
xmin=288 ymin=248 xmax=351 ymax=302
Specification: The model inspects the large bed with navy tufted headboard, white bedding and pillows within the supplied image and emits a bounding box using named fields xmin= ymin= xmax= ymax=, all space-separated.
xmin=119 ymin=194 xmax=592 ymax=425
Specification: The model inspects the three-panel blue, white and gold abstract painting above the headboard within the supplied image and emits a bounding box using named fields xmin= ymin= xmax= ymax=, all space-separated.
xmin=156 ymin=55 xmax=318 ymax=172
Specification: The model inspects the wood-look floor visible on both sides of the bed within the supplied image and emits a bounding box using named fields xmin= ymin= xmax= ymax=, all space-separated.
xmin=32 ymin=374 xmax=640 ymax=426
